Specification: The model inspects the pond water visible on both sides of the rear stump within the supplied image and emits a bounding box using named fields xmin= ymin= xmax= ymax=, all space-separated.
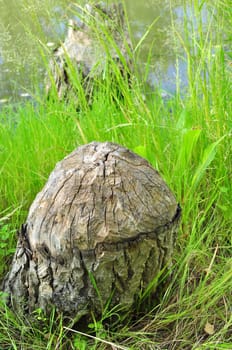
xmin=0 ymin=0 xmax=208 ymax=104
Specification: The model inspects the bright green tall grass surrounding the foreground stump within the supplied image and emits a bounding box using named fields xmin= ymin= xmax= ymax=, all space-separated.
xmin=0 ymin=0 xmax=232 ymax=350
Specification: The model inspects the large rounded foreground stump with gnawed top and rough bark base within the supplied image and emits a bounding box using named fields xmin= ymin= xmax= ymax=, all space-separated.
xmin=3 ymin=142 xmax=180 ymax=317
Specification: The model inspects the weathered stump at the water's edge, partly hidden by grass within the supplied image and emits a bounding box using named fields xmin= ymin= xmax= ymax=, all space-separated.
xmin=46 ymin=2 xmax=132 ymax=98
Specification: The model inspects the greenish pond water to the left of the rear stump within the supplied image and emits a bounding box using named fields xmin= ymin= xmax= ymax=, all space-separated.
xmin=0 ymin=0 xmax=69 ymax=103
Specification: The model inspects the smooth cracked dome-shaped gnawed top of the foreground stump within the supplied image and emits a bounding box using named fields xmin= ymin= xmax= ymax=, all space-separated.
xmin=27 ymin=142 xmax=180 ymax=256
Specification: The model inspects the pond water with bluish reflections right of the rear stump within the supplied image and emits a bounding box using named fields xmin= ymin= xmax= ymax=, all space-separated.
xmin=127 ymin=0 xmax=187 ymax=93
